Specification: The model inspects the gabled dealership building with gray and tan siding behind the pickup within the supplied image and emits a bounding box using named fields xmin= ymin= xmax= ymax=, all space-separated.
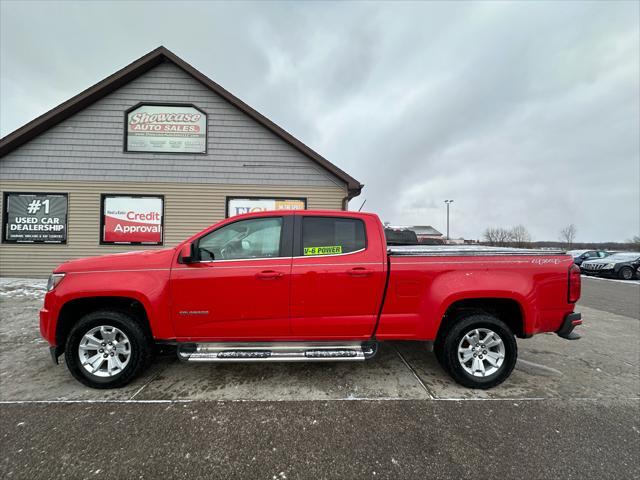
xmin=0 ymin=47 xmax=363 ymax=277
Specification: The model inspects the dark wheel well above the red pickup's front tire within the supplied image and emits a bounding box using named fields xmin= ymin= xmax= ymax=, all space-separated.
xmin=56 ymin=297 xmax=152 ymax=348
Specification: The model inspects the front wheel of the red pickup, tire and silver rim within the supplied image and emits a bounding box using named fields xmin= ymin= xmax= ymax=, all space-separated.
xmin=65 ymin=310 xmax=152 ymax=388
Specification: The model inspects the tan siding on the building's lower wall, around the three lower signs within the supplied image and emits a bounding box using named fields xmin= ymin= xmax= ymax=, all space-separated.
xmin=0 ymin=180 xmax=347 ymax=277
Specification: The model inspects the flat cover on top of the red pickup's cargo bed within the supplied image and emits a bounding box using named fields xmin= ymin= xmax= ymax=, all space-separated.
xmin=387 ymin=245 xmax=566 ymax=257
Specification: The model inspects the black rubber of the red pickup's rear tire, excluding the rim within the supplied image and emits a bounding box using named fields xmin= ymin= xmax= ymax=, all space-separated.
xmin=436 ymin=313 xmax=518 ymax=389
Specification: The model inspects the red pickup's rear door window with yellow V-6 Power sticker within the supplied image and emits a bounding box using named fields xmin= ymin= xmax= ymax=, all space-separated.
xmin=300 ymin=217 xmax=367 ymax=257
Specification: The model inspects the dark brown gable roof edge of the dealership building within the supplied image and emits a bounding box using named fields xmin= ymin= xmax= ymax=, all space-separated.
xmin=0 ymin=46 xmax=364 ymax=198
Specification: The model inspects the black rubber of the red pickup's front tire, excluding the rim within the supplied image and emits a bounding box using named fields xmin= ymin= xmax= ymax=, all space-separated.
xmin=65 ymin=310 xmax=153 ymax=388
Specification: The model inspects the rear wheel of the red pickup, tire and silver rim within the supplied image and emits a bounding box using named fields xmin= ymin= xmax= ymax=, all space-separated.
xmin=438 ymin=313 xmax=518 ymax=389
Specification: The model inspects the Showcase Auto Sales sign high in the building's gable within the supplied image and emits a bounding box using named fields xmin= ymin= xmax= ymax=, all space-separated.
xmin=126 ymin=105 xmax=207 ymax=153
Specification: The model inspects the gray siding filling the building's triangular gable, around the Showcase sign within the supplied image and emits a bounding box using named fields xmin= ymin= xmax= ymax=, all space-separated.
xmin=0 ymin=62 xmax=345 ymax=188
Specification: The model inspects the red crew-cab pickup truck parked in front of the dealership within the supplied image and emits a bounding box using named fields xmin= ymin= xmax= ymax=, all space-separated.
xmin=40 ymin=210 xmax=581 ymax=388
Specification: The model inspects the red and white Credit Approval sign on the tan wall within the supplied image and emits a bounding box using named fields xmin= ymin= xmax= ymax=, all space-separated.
xmin=102 ymin=196 xmax=163 ymax=244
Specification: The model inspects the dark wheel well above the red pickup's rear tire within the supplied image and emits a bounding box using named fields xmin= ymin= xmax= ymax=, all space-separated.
xmin=437 ymin=298 xmax=525 ymax=339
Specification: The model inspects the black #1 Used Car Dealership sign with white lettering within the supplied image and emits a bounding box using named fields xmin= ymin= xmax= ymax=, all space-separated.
xmin=2 ymin=192 xmax=68 ymax=243
